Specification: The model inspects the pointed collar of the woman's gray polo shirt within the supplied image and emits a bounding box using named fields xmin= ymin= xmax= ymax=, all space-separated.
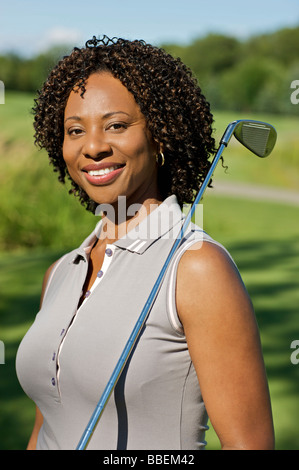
xmin=72 ymin=195 xmax=185 ymax=262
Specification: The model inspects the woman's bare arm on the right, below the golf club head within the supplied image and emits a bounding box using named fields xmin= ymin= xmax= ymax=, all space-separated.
xmin=177 ymin=242 xmax=274 ymax=449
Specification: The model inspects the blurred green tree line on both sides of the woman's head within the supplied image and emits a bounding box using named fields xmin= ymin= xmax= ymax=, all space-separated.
xmin=0 ymin=26 xmax=299 ymax=115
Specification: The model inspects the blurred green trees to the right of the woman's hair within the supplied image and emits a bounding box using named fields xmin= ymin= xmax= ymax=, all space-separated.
xmin=165 ymin=27 xmax=299 ymax=114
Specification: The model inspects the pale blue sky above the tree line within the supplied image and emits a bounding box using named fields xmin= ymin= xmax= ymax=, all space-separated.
xmin=0 ymin=0 xmax=299 ymax=56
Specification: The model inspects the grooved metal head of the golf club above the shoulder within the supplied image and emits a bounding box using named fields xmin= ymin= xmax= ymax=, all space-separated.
xmin=234 ymin=120 xmax=277 ymax=158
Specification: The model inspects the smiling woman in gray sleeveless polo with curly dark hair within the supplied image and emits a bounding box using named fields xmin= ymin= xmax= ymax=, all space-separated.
xmin=17 ymin=37 xmax=273 ymax=449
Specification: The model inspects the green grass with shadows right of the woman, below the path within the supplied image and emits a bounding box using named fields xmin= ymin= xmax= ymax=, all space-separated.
xmin=203 ymin=194 xmax=299 ymax=450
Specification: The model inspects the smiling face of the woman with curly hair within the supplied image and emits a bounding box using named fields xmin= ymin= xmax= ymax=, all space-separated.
xmin=63 ymin=72 xmax=159 ymax=206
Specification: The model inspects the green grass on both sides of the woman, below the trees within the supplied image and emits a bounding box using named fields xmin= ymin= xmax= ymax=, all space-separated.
xmin=0 ymin=94 xmax=299 ymax=450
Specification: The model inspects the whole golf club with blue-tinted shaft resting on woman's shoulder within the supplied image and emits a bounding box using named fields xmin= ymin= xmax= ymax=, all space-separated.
xmin=76 ymin=119 xmax=277 ymax=450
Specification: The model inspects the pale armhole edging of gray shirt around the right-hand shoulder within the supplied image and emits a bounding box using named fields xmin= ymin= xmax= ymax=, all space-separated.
xmin=167 ymin=235 xmax=236 ymax=336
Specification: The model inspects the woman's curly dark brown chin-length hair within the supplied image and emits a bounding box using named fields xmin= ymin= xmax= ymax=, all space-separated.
xmin=33 ymin=36 xmax=215 ymax=211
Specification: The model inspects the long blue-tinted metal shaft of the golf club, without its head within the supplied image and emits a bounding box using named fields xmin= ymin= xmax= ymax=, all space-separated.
xmin=76 ymin=121 xmax=237 ymax=450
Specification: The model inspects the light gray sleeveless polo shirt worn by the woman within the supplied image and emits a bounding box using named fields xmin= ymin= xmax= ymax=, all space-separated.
xmin=16 ymin=196 xmax=232 ymax=450
